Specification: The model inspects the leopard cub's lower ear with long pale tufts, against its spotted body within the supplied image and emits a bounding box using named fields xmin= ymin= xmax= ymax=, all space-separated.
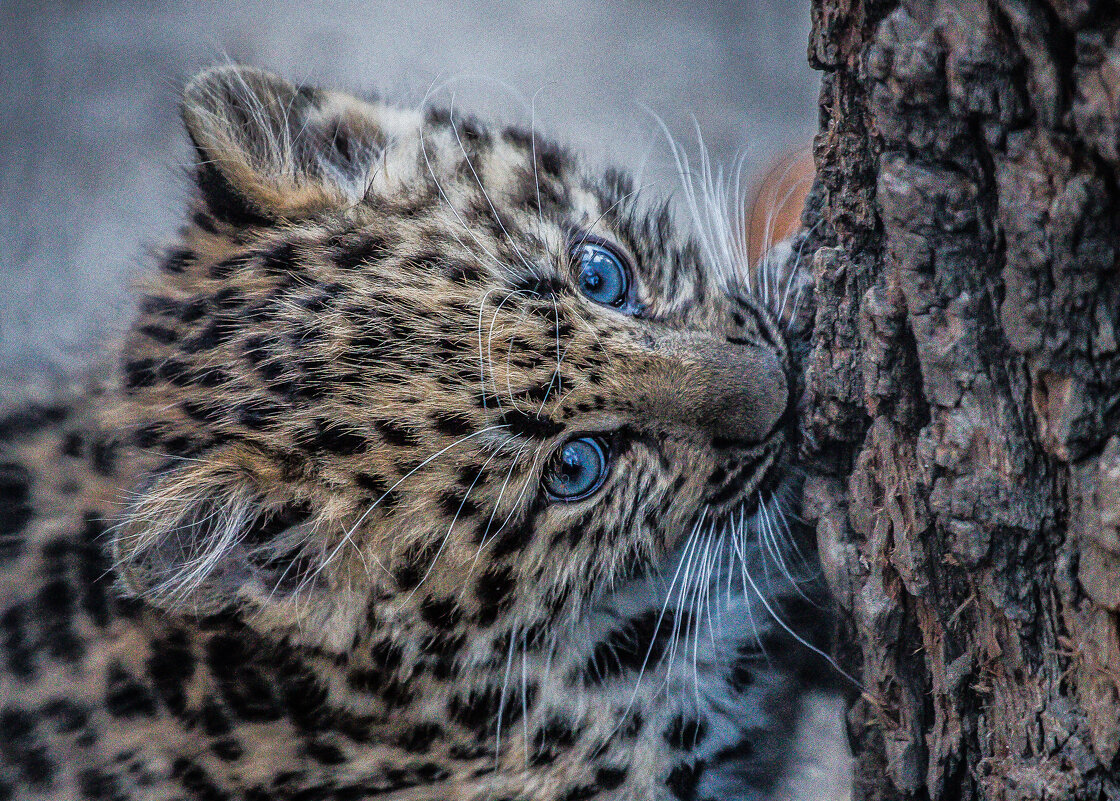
xmin=113 ymin=447 xmax=340 ymax=622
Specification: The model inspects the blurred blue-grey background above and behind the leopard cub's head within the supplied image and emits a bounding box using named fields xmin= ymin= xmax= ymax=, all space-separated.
xmin=0 ymin=0 xmax=818 ymax=375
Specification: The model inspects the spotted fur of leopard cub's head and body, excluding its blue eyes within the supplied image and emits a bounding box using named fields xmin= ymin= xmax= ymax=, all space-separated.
xmin=0 ymin=67 xmax=825 ymax=801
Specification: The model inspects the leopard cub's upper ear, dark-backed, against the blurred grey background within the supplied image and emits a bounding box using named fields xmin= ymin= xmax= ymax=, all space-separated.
xmin=181 ymin=65 xmax=384 ymax=225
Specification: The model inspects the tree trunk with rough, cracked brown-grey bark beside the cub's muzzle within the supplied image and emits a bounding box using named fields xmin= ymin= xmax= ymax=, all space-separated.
xmin=805 ymin=0 xmax=1120 ymax=801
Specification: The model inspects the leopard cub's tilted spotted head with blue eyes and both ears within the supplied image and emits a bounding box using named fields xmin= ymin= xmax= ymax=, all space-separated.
xmin=115 ymin=67 xmax=791 ymax=649
